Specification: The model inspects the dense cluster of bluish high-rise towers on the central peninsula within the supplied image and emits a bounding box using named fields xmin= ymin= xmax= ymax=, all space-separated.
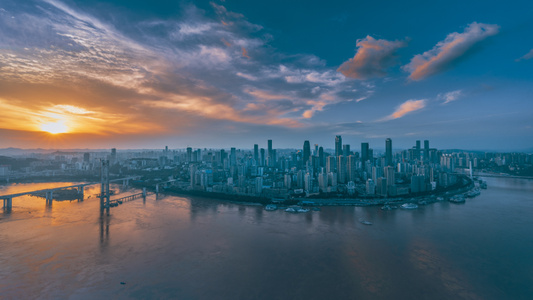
xmin=179 ymin=135 xmax=455 ymax=198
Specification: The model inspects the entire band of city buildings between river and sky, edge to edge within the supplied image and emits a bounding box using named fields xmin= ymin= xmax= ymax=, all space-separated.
xmin=0 ymin=135 xmax=532 ymax=198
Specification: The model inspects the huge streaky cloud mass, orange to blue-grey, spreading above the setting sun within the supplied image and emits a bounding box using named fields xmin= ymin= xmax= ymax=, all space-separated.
xmin=0 ymin=0 xmax=370 ymax=134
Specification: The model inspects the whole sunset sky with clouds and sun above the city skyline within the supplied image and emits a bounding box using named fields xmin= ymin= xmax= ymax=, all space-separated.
xmin=0 ymin=0 xmax=533 ymax=151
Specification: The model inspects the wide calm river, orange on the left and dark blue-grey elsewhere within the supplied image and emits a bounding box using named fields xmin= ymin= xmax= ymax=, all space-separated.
xmin=0 ymin=178 xmax=533 ymax=299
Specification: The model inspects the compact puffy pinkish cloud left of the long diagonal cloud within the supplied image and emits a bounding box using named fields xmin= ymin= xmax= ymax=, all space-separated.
xmin=337 ymin=35 xmax=406 ymax=79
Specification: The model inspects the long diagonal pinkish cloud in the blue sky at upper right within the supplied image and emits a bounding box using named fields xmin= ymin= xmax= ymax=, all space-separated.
xmin=403 ymin=22 xmax=500 ymax=80
